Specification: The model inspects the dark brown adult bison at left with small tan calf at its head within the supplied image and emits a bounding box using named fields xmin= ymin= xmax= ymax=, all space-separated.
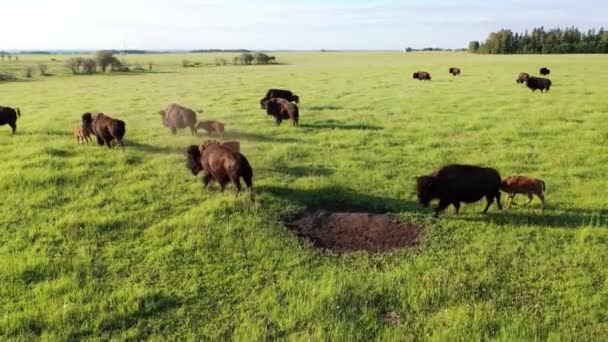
xmin=82 ymin=113 xmax=126 ymax=148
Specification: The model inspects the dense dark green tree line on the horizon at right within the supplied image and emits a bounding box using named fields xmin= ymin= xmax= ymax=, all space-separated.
xmin=469 ymin=26 xmax=608 ymax=54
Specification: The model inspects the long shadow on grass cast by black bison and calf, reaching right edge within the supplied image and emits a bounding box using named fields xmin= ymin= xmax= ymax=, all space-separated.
xmin=460 ymin=208 xmax=608 ymax=228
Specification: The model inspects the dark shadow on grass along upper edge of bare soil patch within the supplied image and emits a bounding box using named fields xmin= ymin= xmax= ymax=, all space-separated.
xmin=258 ymin=186 xmax=418 ymax=214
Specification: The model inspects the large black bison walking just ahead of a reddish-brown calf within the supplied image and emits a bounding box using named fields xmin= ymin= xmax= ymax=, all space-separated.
xmin=416 ymin=164 xmax=502 ymax=216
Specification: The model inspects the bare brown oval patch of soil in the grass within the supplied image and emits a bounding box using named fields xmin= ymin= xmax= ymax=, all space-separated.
xmin=287 ymin=210 xmax=422 ymax=252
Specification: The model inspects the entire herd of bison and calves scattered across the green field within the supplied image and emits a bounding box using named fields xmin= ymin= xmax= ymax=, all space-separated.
xmin=0 ymin=67 xmax=551 ymax=215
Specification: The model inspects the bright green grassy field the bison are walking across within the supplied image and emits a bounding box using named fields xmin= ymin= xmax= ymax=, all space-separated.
xmin=0 ymin=53 xmax=608 ymax=341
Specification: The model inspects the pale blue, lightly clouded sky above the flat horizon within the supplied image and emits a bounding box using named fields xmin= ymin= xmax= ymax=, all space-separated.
xmin=0 ymin=0 xmax=608 ymax=50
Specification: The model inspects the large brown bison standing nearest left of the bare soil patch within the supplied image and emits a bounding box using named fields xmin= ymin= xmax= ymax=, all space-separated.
xmin=186 ymin=141 xmax=253 ymax=194
